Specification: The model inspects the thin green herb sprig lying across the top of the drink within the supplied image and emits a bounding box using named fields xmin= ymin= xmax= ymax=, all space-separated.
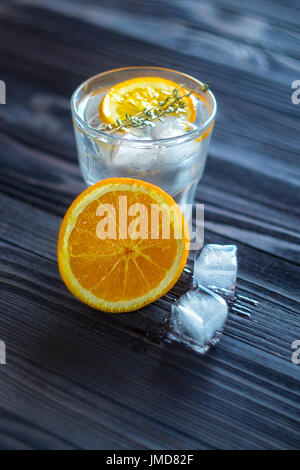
xmin=100 ymin=82 xmax=210 ymax=134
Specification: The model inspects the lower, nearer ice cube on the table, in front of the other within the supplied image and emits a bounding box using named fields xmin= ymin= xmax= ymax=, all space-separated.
xmin=169 ymin=288 xmax=228 ymax=354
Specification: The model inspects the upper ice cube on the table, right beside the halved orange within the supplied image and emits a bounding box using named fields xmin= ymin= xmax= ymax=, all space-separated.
xmin=193 ymin=244 xmax=237 ymax=292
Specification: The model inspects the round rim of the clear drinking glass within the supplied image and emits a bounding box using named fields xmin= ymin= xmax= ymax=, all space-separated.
xmin=71 ymin=66 xmax=217 ymax=147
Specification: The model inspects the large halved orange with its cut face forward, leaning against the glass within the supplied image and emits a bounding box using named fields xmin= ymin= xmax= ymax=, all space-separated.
xmin=57 ymin=178 xmax=189 ymax=312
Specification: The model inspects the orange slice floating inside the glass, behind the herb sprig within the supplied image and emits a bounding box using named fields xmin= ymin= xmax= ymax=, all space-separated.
xmin=99 ymin=77 xmax=196 ymax=124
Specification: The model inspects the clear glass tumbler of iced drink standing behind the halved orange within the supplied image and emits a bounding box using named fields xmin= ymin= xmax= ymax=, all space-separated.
xmin=71 ymin=67 xmax=217 ymax=215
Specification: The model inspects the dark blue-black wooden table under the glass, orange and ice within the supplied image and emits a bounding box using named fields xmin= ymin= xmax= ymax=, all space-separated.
xmin=0 ymin=0 xmax=300 ymax=449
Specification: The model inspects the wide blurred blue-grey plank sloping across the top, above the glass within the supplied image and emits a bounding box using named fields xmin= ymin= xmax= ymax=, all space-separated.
xmin=8 ymin=0 xmax=300 ymax=85
